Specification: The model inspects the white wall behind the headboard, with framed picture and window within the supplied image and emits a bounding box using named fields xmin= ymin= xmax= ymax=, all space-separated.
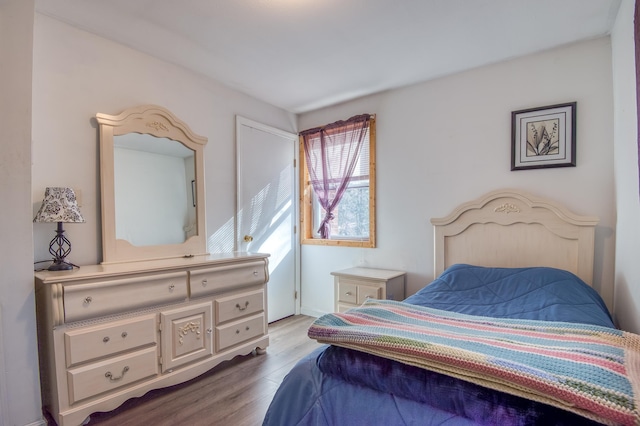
xmin=298 ymin=37 xmax=615 ymax=315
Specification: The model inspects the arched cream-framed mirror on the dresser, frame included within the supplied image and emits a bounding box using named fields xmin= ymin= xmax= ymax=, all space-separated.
xmin=96 ymin=105 xmax=207 ymax=263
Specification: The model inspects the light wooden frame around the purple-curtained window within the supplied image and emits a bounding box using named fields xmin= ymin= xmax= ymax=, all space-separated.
xmin=299 ymin=116 xmax=376 ymax=248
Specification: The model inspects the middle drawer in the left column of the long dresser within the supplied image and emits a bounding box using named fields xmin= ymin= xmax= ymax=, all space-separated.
xmin=64 ymin=315 xmax=158 ymax=367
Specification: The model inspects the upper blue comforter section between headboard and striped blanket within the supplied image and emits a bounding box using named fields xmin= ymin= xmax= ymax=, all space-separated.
xmin=405 ymin=265 xmax=615 ymax=328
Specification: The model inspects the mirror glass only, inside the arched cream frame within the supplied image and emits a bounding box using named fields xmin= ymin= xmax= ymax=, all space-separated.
xmin=113 ymin=133 xmax=196 ymax=246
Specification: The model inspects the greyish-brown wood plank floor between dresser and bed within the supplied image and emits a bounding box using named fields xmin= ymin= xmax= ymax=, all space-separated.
xmin=51 ymin=315 xmax=319 ymax=426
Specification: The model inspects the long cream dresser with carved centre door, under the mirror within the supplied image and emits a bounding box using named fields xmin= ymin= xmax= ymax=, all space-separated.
xmin=36 ymin=253 xmax=269 ymax=426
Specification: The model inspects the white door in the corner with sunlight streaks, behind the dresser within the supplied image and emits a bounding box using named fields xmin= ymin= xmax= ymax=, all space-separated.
xmin=236 ymin=117 xmax=299 ymax=322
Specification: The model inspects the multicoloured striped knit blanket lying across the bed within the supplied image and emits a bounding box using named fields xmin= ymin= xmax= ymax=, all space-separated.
xmin=308 ymin=299 xmax=640 ymax=425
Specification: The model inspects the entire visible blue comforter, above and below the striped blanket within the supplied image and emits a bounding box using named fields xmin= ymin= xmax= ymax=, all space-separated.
xmin=264 ymin=265 xmax=614 ymax=426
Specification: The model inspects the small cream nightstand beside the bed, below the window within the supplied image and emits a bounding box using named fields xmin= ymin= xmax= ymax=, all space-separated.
xmin=331 ymin=268 xmax=406 ymax=312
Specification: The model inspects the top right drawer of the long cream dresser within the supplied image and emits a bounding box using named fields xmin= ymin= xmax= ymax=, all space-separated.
xmin=189 ymin=261 xmax=267 ymax=297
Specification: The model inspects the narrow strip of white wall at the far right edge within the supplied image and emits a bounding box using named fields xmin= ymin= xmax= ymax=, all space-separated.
xmin=611 ymin=0 xmax=640 ymax=333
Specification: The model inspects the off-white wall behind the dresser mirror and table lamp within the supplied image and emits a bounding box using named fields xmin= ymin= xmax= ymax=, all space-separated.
xmin=32 ymin=14 xmax=297 ymax=265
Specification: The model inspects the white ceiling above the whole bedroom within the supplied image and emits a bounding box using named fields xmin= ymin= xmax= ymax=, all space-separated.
xmin=36 ymin=0 xmax=621 ymax=113
